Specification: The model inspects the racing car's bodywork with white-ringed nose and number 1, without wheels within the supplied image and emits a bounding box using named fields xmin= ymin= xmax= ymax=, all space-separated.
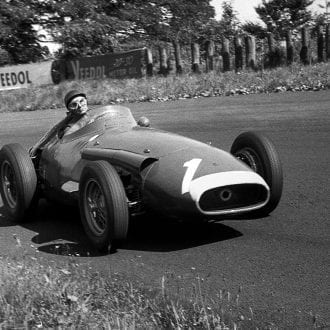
xmin=39 ymin=106 xmax=269 ymax=218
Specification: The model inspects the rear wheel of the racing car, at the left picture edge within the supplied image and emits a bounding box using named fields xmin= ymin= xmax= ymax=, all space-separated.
xmin=0 ymin=143 xmax=37 ymax=222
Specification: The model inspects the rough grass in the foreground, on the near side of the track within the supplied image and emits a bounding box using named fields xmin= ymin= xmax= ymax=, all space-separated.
xmin=0 ymin=246 xmax=323 ymax=330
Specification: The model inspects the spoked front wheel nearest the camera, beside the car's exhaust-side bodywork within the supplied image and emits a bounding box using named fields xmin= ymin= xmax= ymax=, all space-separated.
xmin=79 ymin=161 xmax=129 ymax=252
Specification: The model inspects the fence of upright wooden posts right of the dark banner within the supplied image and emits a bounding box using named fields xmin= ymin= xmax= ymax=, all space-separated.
xmin=146 ymin=24 xmax=330 ymax=76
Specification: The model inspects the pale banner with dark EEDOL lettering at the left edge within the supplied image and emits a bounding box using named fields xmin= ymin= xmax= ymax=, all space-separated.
xmin=0 ymin=61 xmax=53 ymax=90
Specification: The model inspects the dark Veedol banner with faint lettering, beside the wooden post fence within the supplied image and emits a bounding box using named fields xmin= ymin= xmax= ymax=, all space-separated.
xmin=52 ymin=49 xmax=145 ymax=83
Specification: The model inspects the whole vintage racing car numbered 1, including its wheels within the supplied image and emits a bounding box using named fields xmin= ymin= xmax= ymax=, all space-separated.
xmin=0 ymin=105 xmax=283 ymax=251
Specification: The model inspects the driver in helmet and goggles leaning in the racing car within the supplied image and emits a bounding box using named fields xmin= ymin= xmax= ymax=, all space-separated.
xmin=29 ymin=90 xmax=90 ymax=157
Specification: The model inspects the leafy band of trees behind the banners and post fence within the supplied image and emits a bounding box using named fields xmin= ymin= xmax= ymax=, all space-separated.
xmin=0 ymin=0 xmax=326 ymax=65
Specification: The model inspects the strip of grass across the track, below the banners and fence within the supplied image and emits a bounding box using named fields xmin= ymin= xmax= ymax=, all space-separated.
xmin=0 ymin=63 xmax=330 ymax=112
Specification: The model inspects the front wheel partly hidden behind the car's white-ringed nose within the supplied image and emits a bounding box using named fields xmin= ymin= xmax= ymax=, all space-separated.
xmin=230 ymin=132 xmax=283 ymax=215
